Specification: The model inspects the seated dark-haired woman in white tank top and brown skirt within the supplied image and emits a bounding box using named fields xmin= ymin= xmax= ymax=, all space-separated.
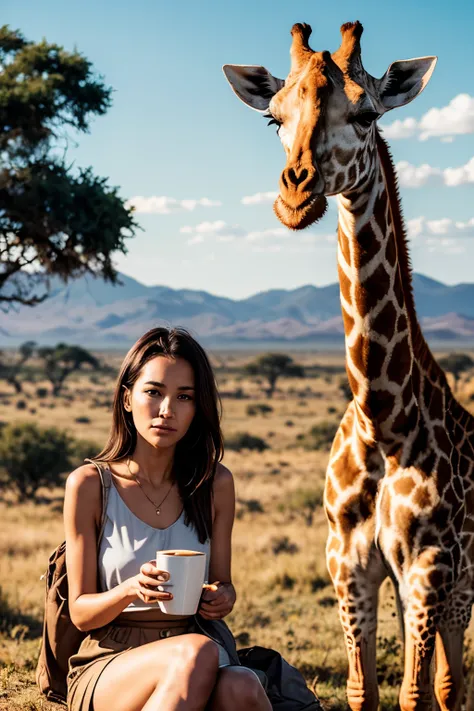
xmin=64 ymin=328 xmax=271 ymax=711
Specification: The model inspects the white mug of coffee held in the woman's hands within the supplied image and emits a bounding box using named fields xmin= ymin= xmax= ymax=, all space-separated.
xmin=156 ymin=549 xmax=206 ymax=615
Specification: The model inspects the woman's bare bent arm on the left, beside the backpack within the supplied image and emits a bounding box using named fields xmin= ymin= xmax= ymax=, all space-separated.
xmin=64 ymin=464 xmax=137 ymax=632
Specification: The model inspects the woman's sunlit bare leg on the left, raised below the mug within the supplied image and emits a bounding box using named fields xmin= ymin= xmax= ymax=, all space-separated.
xmin=92 ymin=634 xmax=219 ymax=711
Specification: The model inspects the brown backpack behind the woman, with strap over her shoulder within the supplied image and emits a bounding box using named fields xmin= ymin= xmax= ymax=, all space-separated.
xmin=36 ymin=459 xmax=111 ymax=706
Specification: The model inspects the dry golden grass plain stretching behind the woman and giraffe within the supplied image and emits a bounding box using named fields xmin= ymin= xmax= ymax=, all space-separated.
xmin=0 ymin=350 xmax=474 ymax=711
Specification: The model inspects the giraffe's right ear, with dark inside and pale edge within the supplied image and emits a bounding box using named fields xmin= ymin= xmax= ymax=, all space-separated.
xmin=379 ymin=57 xmax=438 ymax=111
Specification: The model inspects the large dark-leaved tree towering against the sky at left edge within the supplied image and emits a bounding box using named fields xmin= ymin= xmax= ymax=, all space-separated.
xmin=0 ymin=25 xmax=137 ymax=309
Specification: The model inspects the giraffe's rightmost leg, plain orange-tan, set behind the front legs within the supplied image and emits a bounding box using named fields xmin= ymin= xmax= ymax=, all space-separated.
xmin=434 ymin=626 xmax=464 ymax=711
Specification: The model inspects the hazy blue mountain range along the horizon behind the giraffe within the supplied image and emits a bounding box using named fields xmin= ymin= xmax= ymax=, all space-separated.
xmin=0 ymin=273 xmax=474 ymax=348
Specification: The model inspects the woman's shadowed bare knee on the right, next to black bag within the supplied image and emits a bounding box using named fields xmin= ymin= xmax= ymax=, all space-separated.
xmin=206 ymin=666 xmax=272 ymax=711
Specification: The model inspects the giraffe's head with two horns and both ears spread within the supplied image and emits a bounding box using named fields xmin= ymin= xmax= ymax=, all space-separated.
xmin=223 ymin=22 xmax=436 ymax=230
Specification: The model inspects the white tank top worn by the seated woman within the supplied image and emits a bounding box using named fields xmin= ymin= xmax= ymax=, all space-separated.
xmin=98 ymin=476 xmax=211 ymax=612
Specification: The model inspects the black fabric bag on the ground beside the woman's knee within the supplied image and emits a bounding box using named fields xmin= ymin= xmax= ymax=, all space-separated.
xmin=237 ymin=647 xmax=322 ymax=711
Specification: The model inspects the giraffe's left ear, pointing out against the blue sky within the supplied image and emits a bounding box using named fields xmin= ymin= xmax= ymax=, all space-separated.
xmin=222 ymin=64 xmax=285 ymax=113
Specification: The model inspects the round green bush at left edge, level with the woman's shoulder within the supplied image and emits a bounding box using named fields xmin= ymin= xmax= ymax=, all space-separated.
xmin=0 ymin=423 xmax=72 ymax=501
